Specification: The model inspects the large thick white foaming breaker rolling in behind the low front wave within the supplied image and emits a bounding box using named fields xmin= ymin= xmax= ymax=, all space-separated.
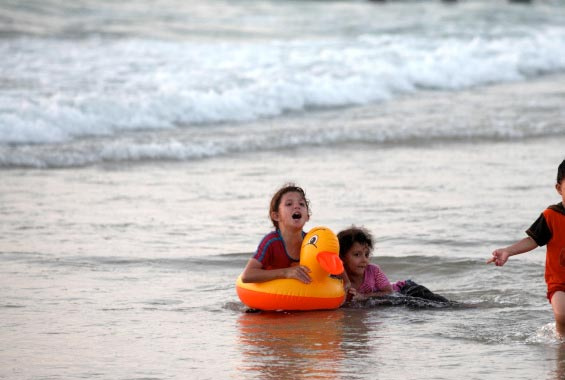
xmin=0 ymin=27 xmax=565 ymax=147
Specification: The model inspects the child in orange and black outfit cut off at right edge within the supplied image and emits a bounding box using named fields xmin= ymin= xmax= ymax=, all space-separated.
xmin=487 ymin=160 xmax=565 ymax=337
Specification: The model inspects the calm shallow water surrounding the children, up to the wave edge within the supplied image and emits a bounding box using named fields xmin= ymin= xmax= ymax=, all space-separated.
xmin=0 ymin=129 xmax=565 ymax=379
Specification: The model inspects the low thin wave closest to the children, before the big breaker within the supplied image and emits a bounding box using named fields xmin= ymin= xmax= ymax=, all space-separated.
xmin=0 ymin=101 xmax=563 ymax=168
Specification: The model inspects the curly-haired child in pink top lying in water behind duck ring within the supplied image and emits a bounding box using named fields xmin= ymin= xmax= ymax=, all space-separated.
xmin=337 ymin=226 xmax=449 ymax=304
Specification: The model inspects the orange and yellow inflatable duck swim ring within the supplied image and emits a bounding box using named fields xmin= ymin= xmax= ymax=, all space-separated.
xmin=236 ymin=227 xmax=345 ymax=310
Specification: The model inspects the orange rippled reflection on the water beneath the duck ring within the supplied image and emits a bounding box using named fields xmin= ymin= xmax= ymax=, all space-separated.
xmin=237 ymin=309 xmax=371 ymax=379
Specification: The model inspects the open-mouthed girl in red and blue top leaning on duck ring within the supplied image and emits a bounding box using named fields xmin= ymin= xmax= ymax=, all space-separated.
xmin=241 ymin=183 xmax=311 ymax=283
